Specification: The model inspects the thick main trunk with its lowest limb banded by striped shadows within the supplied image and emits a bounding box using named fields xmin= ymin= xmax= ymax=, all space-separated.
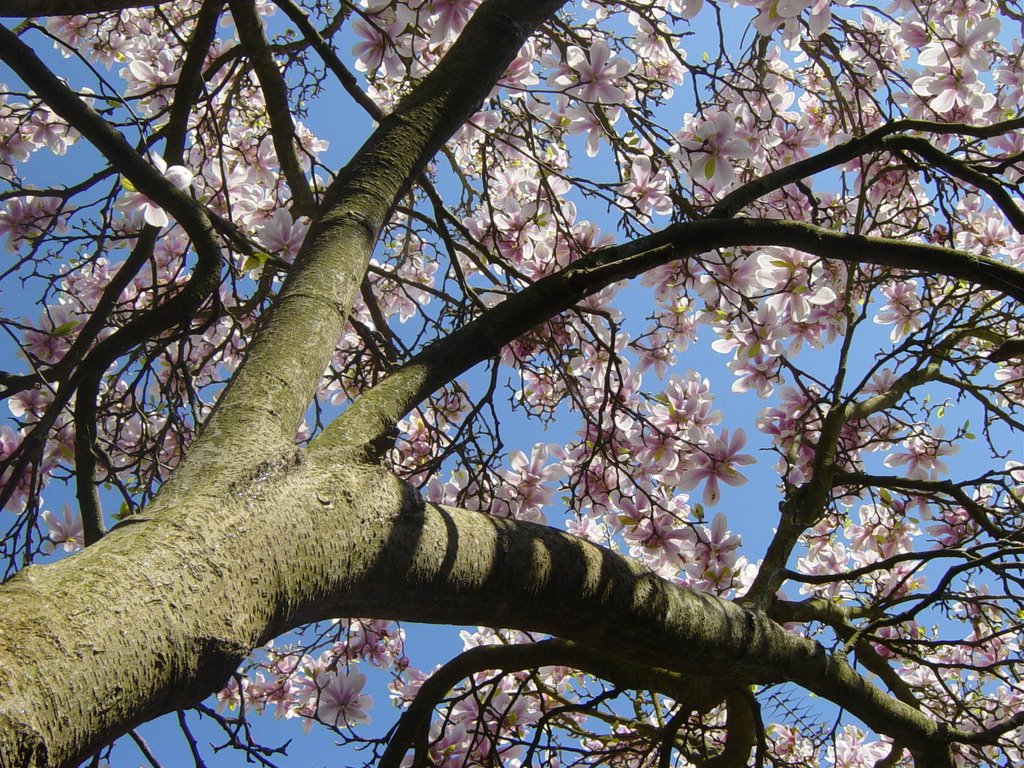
xmin=0 ymin=458 xmax=955 ymax=768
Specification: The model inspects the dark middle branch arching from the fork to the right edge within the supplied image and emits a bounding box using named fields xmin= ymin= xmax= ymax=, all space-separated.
xmin=318 ymin=218 xmax=1024 ymax=455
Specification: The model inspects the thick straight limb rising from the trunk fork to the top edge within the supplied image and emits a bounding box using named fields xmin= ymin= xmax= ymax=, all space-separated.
xmin=191 ymin=0 xmax=564 ymax=474
